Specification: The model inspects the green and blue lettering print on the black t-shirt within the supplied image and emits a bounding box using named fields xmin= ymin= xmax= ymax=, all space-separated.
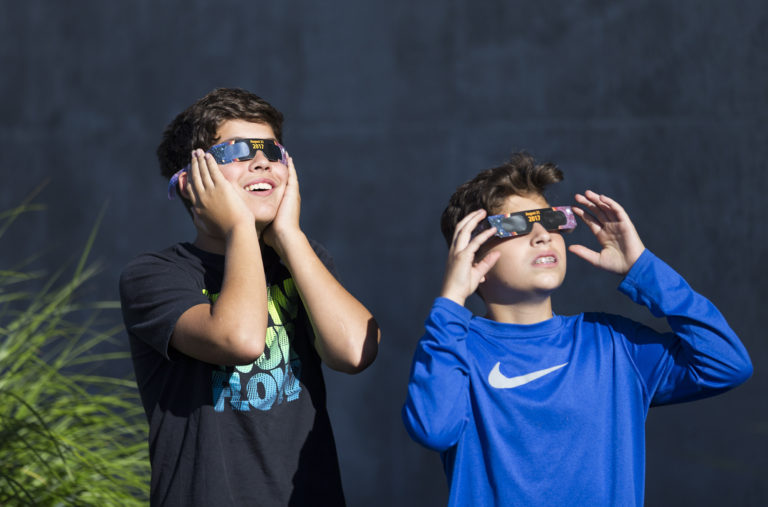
xmin=212 ymin=278 xmax=308 ymax=412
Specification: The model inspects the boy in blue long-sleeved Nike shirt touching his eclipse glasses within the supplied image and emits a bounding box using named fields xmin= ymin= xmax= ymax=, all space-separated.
xmin=403 ymin=153 xmax=752 ymax=506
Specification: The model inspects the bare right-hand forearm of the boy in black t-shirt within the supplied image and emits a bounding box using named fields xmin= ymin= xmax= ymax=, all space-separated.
xmin=278 ymin=231 xmax=380 ymax=373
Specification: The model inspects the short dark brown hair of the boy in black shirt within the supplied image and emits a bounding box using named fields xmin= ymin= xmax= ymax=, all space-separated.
xmin=157 ymin=88 xmax=283 ymax=209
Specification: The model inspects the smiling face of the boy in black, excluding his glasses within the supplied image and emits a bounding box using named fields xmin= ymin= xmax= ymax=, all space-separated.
xmin=210 ymin=120 xmax=288 ymax=231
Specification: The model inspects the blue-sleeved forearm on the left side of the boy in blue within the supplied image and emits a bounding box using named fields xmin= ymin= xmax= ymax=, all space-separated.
xmin=402 ymin=299 xmax=471 ymax=451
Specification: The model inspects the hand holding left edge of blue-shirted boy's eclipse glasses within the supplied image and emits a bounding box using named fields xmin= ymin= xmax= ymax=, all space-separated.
xmin=440 ymin=209 xmax=501 ymax=306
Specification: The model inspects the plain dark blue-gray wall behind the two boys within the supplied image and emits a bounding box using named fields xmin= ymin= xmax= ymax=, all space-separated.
xmin=0 ymin=0 xmax=768 ymax=506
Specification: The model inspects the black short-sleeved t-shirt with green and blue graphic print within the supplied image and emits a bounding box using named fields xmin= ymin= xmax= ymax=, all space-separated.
xmin=120 ymin=243 xmax=344 ymax=506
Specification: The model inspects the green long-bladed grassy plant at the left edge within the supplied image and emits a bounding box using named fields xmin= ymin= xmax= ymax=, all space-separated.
xmin=0 ymin=194 xmax=150 ymax=506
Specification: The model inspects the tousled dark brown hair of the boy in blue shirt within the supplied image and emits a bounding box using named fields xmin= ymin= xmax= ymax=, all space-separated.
xmin=440 ymin=151 xmax=563 ymax=245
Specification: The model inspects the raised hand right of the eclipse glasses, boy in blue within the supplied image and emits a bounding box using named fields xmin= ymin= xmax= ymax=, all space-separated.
xmin=568 ymin=190 xmax=645 ymax=275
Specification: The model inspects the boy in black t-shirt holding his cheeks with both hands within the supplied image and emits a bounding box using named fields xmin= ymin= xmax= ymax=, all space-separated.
xmin=120 ymin=89 xmax=380 ymax=506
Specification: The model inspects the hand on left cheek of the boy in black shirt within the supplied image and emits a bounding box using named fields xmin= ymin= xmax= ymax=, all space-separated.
xmin=179 ymin=149 xmax=255 ymax=237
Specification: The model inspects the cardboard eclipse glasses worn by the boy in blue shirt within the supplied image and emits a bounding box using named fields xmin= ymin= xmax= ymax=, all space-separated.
xmin=475 ymin=206 xmax=576 ymax=238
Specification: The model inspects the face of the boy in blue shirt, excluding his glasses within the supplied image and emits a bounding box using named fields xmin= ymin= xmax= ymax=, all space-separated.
xmin=478 ymin=194 xmax=566 ymax=302
